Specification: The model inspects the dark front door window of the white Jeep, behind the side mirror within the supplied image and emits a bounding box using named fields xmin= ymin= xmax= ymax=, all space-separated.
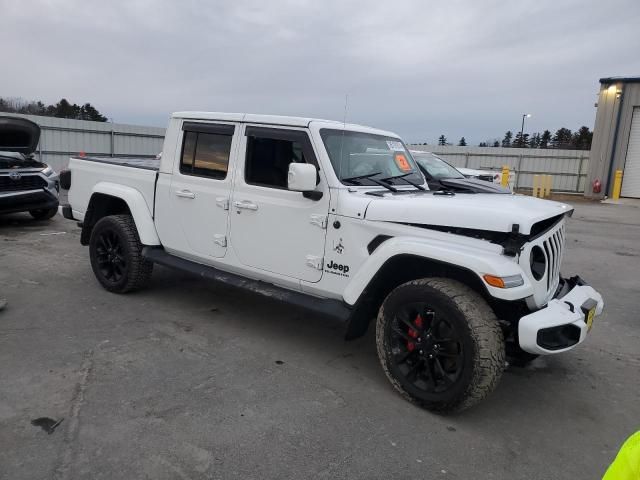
xmin=245 ymin=136 xmax=307 ymax=188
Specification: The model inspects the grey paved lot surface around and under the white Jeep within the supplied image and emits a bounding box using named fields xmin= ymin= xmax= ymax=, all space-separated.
xmin=0 ymin=203 xmax=640 ymax=480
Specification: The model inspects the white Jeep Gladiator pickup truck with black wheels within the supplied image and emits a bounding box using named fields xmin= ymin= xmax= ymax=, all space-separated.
xmin=60 ymin=112 xmax=604 ymax=411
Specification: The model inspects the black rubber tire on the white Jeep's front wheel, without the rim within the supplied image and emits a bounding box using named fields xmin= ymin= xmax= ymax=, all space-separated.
xmin=376 ymin=278 xmax=505 ymax=413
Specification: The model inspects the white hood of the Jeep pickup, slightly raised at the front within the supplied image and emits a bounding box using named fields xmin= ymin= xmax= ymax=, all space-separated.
xmin=365 ymin=192 xmax=573 ymax=235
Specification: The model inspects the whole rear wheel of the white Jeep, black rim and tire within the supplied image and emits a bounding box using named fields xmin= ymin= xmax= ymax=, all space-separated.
xmin=89 ymin=215 xmax=153 ymax=293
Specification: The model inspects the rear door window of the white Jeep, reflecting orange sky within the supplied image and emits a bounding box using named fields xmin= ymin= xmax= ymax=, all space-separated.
xmin=180 ymin=131 xmax=233 ymax=180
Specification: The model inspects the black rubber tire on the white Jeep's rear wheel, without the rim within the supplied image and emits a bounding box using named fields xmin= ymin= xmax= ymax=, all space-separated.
xmin=89 ymin=215 xmax=153 ymax=293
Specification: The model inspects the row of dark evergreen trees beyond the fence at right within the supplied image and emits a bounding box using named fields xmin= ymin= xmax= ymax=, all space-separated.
xmin=423 ymin=126 xmax=593 ymax=150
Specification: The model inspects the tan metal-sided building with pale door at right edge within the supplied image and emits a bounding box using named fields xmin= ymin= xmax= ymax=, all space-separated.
xmin=585 ymin=77 xmax=640 ymax=198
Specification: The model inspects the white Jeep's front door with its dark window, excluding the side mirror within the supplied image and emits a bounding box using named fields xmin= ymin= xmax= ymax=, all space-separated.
xmin=230 ymin=126 xmax=329 ymax=282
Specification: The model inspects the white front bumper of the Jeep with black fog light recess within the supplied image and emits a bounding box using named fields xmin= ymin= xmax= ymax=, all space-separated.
xmin=518 ymin=277 xmax=604 ymax=355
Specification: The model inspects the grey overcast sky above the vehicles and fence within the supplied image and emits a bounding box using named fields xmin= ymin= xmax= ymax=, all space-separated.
xmin=0 ymin=0 xmax=640 ymax=144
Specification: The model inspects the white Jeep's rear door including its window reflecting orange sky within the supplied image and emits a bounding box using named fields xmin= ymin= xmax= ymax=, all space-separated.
xmin=170 ymin=121 xmax=239 ymax=259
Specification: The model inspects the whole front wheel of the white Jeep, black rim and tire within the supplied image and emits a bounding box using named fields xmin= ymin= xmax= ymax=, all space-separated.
xmin=376 ymin=278 xmax=505 ymax=412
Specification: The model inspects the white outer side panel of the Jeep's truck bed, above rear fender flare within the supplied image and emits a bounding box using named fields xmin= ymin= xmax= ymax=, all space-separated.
xmin=69 ymin=157 xmax=160 ymax=220
